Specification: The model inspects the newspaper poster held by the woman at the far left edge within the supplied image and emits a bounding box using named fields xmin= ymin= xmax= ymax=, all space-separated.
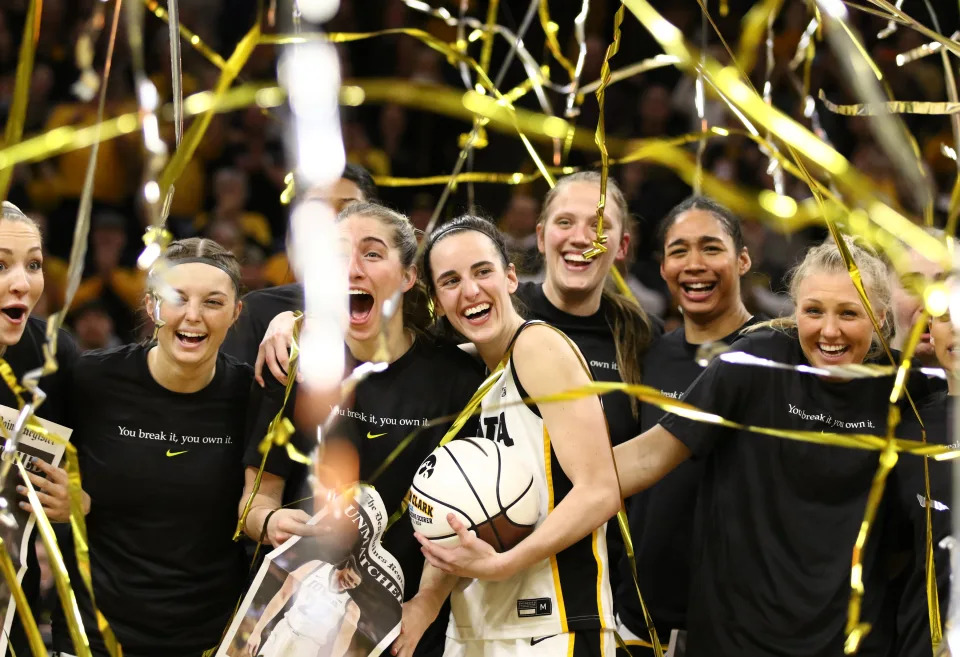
xmin=0 ymin=405 xmax=73 ymax=656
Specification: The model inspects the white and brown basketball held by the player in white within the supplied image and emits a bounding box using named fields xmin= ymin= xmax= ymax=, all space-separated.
xmin=408 ymin=438 xmax=540 ymax=552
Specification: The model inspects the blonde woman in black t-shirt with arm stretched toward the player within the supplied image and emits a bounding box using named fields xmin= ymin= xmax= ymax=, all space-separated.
xmin=615 ymin=241 xmax=908 ymax=657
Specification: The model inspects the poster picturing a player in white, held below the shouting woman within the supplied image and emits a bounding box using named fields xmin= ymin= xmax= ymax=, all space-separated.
xmin=217 ymin=486 xmax=403 ymax=657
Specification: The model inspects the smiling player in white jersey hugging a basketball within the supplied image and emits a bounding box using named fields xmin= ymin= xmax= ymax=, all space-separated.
xmin=402 ymin=216 xmax=619 ymax=656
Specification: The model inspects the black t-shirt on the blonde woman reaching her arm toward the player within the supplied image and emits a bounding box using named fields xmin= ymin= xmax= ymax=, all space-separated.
xmin=660 ymin=329 xmax=893 ymax=657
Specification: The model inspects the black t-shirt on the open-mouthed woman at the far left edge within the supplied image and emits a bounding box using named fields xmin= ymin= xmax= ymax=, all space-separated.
xmin=0 ymin=317 xmax=77 ymax=655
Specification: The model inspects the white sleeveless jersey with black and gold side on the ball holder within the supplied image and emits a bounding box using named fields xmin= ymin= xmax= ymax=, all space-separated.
xmin=447 ymin=324 xmax=616 ymax=640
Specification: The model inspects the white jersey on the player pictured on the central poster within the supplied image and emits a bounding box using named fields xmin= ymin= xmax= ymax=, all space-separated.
xmin=286 ymin=564 xmax=350 ymax=644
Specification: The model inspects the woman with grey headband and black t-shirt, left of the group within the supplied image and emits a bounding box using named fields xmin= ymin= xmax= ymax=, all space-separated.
xmin=41 ymin=238 xmax=253 ymax=657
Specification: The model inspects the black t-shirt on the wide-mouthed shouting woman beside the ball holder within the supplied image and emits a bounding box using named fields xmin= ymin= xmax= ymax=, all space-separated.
xmin=246 ymin=337 xmax=484 ymax=655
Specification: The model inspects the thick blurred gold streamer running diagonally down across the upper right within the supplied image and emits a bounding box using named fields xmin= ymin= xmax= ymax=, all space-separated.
xmin=623 ymin=0 xmax=947 ymax=270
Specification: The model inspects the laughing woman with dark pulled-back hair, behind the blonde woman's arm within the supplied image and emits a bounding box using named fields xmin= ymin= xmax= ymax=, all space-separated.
xmin=615 ymin=196 xmax=756 ymax=657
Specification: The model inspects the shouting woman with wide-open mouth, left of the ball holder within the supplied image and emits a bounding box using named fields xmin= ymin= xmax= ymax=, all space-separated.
xmin=240 ymin=203 xmax=483 ymax=655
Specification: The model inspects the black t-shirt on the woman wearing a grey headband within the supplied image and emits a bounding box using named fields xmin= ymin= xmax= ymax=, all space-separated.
xmin=54 ymin=345 xmax=253 ymax=657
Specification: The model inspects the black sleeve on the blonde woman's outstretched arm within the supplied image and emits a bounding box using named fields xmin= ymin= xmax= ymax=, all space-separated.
xmin=660 ymin=360 xmax=744 ymax=458
